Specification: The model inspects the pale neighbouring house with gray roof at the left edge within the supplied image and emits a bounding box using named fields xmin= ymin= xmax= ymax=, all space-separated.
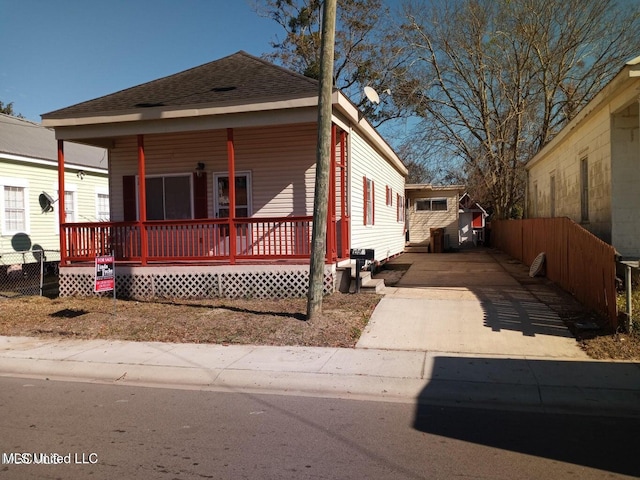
xmin=0 ymin=114 xmax=109 ymax=265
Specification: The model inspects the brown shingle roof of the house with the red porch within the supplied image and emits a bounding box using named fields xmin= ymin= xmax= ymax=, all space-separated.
xmin=42 ymin=51 xmax=318 ymax=119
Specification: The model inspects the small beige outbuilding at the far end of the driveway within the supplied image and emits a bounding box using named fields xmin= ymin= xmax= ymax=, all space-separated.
xmin=405 ymin=184 xmax=464 ymax=252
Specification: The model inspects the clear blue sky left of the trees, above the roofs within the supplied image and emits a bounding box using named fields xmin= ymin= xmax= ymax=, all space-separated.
xmin=0 ymin=0 xmax=282 ymax=122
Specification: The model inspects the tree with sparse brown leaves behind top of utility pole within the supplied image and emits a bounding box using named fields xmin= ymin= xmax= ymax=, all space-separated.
xmin=254 ymin=0 xmax=407 ymax=126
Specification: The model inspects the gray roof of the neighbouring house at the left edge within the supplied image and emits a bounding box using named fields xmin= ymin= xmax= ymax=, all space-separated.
xmin=0 ymin=114 xmax=108 ymax=170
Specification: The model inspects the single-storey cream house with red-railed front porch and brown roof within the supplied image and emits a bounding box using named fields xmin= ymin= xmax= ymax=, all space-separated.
xmin=42 ymin=51 xmax=407 ymax=297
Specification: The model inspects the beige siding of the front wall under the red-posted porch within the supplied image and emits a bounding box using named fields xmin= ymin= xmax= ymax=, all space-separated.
xmin=110 ymin=124 xmax=316 ymax=221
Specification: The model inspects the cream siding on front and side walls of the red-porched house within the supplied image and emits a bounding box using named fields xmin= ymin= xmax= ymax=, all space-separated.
xmin=109 ymin=123 xmax=404 ymax=260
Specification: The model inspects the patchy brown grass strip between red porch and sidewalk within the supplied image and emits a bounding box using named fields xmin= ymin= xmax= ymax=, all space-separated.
xmin=0 ymin=293 xmax=381 ymax=347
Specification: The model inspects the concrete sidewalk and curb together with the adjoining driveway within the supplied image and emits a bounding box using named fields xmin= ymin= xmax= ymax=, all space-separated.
xmin=0 ymin=250 xmax=640 ymax=417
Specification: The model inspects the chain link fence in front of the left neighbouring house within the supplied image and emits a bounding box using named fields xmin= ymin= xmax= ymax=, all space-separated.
xmin=0 ymin=250 xmax=60 ymax=298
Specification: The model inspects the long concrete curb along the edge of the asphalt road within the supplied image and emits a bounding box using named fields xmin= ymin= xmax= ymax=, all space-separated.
xmin=0 ymin=357 xmax=640 ymax=417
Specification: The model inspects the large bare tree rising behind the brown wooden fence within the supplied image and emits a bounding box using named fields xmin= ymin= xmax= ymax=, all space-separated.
xmin=395 ymin=0 xmax=640 ymax=218
